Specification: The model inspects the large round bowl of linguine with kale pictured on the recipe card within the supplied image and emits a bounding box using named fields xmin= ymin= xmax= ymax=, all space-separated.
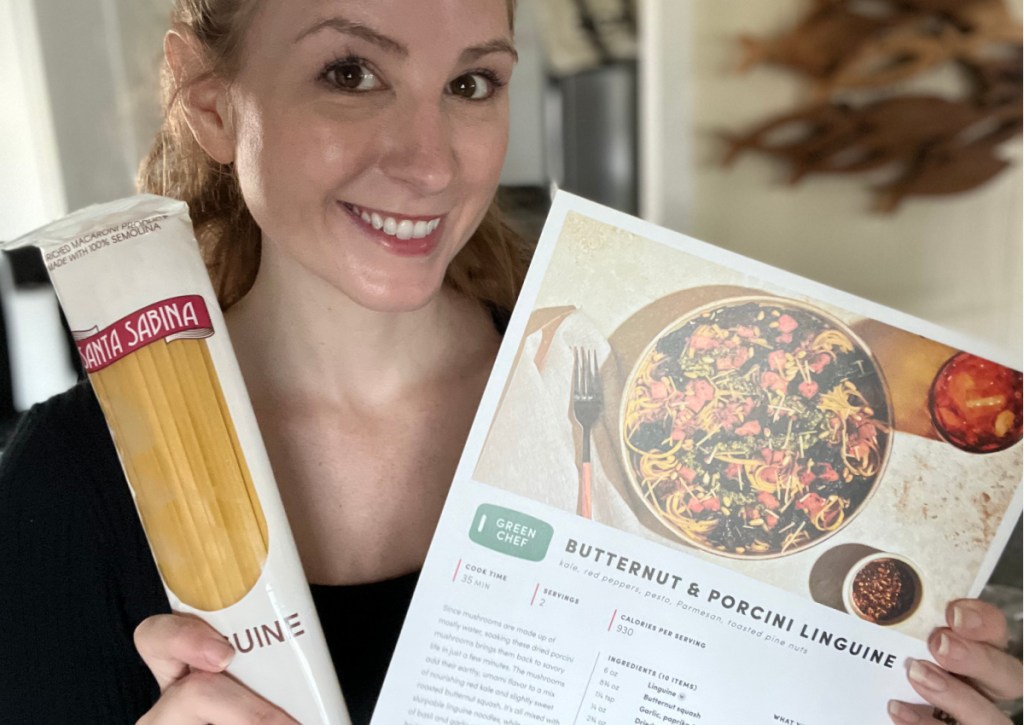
xmin=620 ymin=297 xmax=893 ymax=559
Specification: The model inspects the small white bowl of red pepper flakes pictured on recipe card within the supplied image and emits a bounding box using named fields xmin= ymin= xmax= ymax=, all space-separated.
xmin=843 ymin=552 xmax=924 ymax=626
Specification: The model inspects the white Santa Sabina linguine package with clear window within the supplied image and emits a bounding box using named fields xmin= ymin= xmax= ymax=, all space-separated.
xmin=6 ymin=195 xmax=349 ymax=725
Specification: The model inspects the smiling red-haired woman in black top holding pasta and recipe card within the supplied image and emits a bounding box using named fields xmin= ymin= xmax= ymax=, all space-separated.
xmin=0 ymin=0 xmax=1020 ymax=725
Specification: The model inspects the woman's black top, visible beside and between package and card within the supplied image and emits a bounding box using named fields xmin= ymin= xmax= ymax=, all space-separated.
xmin=0 ymin=384 xmax=417 ymax=725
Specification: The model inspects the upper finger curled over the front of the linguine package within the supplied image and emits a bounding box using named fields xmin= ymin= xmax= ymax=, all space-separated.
xmin=135 ymin=614 xmax=234 ymax=690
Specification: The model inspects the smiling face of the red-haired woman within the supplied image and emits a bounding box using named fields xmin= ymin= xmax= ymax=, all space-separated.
xmin=226 ymin=0 xmax=515 ymax=311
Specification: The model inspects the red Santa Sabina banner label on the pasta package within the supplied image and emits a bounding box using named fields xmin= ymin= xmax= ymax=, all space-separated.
xmin=73 ymin=295 xmax=213 ymax=373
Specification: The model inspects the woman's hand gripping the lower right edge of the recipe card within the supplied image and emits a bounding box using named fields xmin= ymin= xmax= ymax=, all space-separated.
xmin=889 ymin=599 xmax=1022 ymax=725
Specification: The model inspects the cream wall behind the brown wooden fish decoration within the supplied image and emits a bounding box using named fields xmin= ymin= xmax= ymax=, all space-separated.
xmin=641 ymin=0 xmax=1022 ymax=360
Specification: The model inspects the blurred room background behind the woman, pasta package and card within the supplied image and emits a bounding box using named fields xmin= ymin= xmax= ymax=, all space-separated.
xmin=0 ymin=0 xmax=1024 ymax=696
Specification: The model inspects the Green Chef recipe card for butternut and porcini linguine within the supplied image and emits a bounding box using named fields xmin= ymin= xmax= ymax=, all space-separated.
xmin=374 ymin=193 xmax=1022 ymax=725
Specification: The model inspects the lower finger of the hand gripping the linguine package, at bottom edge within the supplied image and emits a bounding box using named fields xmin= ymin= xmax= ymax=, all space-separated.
xmin=137 ymin=672 xmax=298 ymax=725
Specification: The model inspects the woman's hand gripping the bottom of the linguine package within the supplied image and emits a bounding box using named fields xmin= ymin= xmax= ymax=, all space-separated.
xmin=135 ymin=614 xmax=297 ymax=725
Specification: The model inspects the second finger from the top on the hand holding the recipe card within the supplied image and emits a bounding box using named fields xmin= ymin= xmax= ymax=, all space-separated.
xmin=928 ymin=629 xmax=1024 ymax=699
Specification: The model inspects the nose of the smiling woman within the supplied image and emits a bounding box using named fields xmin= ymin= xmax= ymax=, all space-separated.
xmin=381 ymin=99 xmax=458 ymax=195
